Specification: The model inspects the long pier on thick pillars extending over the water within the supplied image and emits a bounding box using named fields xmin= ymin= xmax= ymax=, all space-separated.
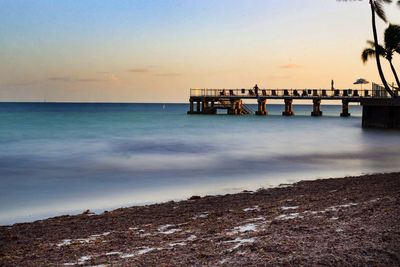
xmin=188 ymin=87 xmax=389 ymax=117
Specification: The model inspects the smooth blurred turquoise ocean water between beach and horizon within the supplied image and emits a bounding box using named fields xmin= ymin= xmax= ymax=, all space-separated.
xmin=0 ymin=103 xmax=400 ymax=224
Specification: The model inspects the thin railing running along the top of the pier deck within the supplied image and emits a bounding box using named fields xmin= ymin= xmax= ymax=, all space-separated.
xmin=190 ymin=88 xmax=390 ymax=99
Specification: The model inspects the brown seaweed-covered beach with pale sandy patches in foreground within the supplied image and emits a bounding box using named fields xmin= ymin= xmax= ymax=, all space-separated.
xmin=0 ymin=173 xmax=400 ymax=266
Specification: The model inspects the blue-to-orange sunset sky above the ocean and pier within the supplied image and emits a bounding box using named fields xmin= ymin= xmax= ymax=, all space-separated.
xmin=0 ymin=0 xmax=400 ymax=103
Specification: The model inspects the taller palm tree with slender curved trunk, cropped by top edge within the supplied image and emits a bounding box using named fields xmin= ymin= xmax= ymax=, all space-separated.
xmin=369 ymin=0 xmax=396 ymax=98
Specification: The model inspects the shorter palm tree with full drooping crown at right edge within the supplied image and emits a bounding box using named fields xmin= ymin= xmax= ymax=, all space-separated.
xmin=361 ymin=24 xmax=400 ymax=88
